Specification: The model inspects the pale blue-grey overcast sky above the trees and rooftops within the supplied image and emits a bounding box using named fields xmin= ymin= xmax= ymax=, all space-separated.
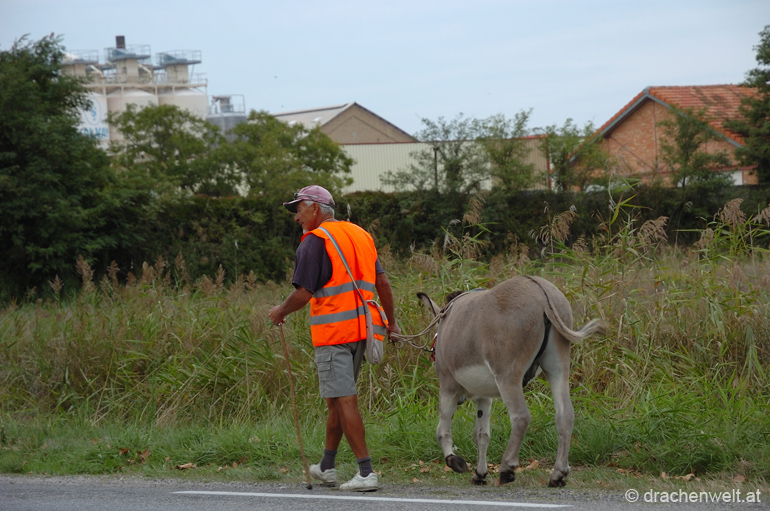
xmin=0 ymin=0 xmax=770 ymax=134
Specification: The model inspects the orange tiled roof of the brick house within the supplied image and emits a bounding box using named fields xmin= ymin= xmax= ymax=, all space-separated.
xmin=597 ymin=85 xmax=756 ymax=144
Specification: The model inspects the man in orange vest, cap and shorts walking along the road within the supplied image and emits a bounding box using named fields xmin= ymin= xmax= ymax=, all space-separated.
xmin=268 ymin=185 xmax=401 ymax=491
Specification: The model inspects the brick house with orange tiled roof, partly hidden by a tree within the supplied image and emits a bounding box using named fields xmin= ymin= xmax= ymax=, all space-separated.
xmin=597 ymin=85 xmax=757 ymax=185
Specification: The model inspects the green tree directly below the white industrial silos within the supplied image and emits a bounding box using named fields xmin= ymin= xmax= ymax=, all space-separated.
xmin=107 ymin=104 xmax=234 ymax=195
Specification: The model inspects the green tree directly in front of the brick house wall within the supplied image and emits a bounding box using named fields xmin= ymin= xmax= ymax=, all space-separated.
xmin=658 ymin=108 xmax=732 ymax=190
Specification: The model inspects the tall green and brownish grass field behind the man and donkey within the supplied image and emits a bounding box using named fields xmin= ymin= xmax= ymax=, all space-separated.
xmin=0 ymin=195 xmax=770 ymax=486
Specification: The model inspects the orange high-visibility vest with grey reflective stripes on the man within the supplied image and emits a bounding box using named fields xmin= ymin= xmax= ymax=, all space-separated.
xmin=302 ymin=222 xmax=387 ymax=346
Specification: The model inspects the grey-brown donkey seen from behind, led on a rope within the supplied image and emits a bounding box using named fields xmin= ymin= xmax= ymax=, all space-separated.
xmin=417 ymin=276 xmax=604 ymax=487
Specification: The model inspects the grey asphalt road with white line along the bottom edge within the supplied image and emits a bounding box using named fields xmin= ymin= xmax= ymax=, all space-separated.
xmin=0 ymin=475 xmax=770 ymax=511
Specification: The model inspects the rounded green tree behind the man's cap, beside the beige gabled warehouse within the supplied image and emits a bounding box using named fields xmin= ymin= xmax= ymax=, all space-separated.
xmin=225 ymin=110 xmax=353 ymax=198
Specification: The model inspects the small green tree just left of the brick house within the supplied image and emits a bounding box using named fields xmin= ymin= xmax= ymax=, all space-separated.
xmin=539 ymin=119 xmax=609 ymax=191
